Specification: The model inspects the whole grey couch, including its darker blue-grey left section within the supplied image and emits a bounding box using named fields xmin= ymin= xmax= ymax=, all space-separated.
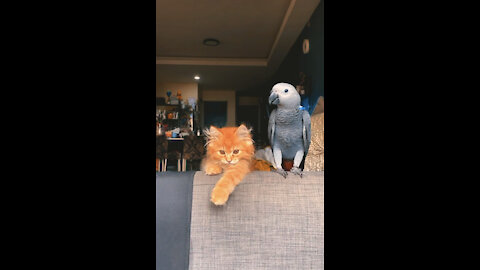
xmin=157 ymin=172 xmax=324 ymax=270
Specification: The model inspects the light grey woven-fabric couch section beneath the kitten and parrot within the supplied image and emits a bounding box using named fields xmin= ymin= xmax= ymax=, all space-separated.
xmin=189 ymin=172 xmax=323 ymax=270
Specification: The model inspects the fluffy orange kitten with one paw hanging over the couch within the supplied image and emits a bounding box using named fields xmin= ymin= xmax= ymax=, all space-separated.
xmin=202 ymin=125 xmax=255 ymax=205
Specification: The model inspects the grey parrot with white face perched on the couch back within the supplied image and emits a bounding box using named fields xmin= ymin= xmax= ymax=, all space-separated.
xmin=268 ymin=83 xmax=311 ymax=178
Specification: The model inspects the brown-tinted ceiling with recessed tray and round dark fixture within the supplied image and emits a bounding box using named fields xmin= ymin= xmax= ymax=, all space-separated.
xmin=156 ymin=0 xmax=320 ymax=94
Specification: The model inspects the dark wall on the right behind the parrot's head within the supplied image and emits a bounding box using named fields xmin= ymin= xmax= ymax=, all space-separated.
xmin=270 ymin=0 xmax=324 ymax=114
